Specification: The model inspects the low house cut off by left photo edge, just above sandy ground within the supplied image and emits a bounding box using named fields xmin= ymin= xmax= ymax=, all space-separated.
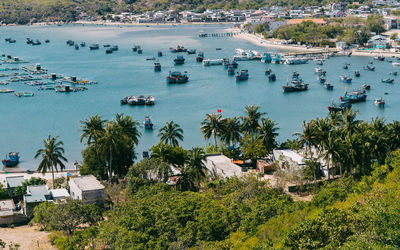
xmin=0 ymin=199 xmax=27 ymax=226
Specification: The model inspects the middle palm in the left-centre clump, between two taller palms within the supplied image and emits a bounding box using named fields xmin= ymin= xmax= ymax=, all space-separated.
xmin=98 ymin=122 xmax=128 ymax=178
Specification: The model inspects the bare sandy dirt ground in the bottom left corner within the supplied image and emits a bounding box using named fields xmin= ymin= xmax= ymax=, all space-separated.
xmin=0 ymin=226 xmax=56 ymax=250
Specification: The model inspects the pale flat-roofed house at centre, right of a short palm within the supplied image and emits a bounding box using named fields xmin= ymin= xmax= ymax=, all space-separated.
xmin=204 ymin=154 xmax=242 ymax=178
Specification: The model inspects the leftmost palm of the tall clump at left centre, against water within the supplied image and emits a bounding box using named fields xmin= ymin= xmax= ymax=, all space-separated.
xmin=81 ymin=115 xmax=106 ymax=170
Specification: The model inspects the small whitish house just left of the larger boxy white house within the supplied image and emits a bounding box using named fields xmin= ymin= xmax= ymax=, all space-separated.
xmin=24 ymin=185 xmax=51 ymax=217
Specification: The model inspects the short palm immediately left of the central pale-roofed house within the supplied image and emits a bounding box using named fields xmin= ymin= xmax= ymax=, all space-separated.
xmin=186 ymin=147 xmax=207 ymax=186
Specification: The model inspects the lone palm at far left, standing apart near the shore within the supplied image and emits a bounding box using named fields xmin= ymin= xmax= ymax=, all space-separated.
xmin=34 ymin=135 xmax=68 ymax=188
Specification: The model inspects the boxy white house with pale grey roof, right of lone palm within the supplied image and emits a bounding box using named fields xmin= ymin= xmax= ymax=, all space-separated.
xmin=68 ymin=175 xmax=106 ymax=204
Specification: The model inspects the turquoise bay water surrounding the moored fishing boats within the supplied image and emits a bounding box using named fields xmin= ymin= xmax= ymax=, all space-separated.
xmin=0 ymin=25 xmax=400 ymax=169
